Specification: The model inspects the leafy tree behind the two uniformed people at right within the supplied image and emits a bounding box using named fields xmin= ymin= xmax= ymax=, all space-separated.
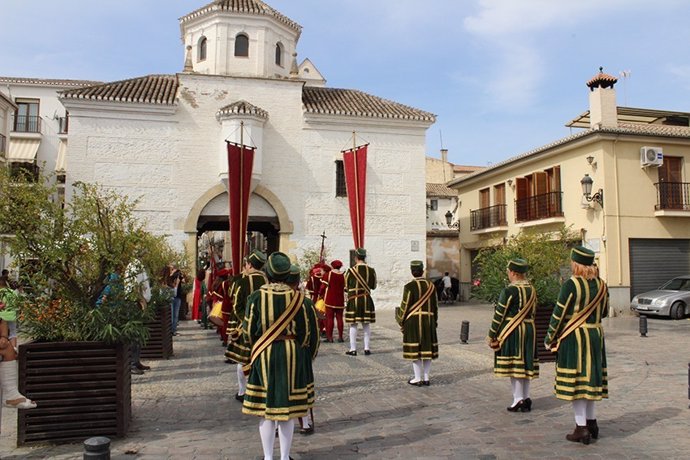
xmin=472 ymin=226 xmax=577 ymax=305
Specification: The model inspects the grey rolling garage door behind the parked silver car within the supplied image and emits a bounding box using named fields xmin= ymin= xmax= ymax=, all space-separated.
xmin=630 ymin=238 xmax=690 ymax=299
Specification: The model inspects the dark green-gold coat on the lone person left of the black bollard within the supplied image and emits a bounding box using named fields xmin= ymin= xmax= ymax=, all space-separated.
xmin=395 ymin=277 xmax=438 ymax=360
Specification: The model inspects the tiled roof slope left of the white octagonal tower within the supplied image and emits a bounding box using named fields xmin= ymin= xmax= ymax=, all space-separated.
xmin=60 ymin=75 xmax=179 ymax=105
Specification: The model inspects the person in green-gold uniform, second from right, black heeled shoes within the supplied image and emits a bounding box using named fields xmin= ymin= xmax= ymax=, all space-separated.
xmin=487 ymin=258 xmax=539 ymax=412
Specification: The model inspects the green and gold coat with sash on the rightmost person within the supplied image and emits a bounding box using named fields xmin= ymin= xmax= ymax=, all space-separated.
xmin=544 ymin=276 xmax=608 ymax=401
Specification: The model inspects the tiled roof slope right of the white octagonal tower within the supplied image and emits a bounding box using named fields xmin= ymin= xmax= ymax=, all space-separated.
xmin=302 ymin=86 xmax=436 ymax=123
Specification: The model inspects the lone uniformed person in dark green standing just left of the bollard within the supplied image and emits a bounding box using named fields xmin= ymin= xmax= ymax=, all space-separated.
xmin=395 ymin=260 xmax=438 ymax=386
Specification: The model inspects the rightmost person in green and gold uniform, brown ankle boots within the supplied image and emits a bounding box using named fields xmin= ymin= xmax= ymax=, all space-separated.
xmin=544 ymin=246 xmax=609 ymax=444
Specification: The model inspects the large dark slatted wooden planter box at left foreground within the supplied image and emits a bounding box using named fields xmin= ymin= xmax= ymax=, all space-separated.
xmin=17 ymin=342 xmax=132 ymax=446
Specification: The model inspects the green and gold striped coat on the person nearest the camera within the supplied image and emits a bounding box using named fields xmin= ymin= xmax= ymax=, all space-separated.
xmin=242 ymin=283 xmax=319 ymax=421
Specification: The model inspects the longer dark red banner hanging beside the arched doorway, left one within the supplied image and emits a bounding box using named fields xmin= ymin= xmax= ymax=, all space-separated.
xmin=228 ymin=142 xmax=254 ymax=273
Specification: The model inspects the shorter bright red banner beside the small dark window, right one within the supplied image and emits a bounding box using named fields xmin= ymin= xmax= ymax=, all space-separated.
xmin=343 ymin=145 xmax=367 ymax=249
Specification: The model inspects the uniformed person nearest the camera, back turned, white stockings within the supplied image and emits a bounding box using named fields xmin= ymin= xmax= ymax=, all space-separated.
xmin=242 ymin=252 xmax=319 ymax=458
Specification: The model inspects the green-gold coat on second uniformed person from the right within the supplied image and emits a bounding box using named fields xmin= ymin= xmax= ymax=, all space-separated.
xmin=488 ymin=280 xmax=539 ymax=379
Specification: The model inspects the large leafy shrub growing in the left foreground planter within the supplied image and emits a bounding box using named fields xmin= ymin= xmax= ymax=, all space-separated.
xmin=0 ymin=168 xmax=173 ymax=342
